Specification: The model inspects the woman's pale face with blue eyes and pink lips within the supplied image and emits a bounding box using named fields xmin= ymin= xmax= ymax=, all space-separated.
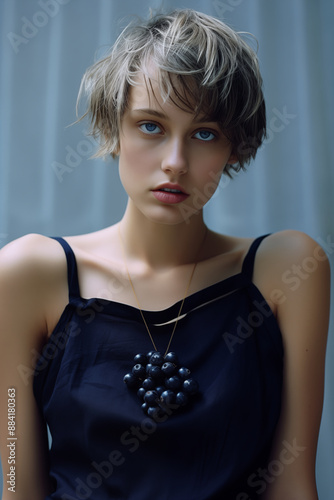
xmin=119 ymin=71 xmax=236 ymax=224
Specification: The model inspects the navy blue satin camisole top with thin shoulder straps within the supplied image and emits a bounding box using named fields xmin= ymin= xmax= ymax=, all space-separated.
xmin=34 ymin=236 xmax=283 ymax=500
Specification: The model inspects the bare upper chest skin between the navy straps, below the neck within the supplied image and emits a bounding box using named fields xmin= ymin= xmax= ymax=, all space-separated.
xmin=78 ymin=255 xmax=247 ymax=311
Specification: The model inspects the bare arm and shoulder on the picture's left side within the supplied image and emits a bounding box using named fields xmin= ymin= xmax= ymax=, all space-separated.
xmin=0 ymin=235 xmax=66 ymax=500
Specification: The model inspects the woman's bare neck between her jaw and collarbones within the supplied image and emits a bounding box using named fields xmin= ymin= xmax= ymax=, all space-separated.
xmin=120 ymin=200 xmax=207 ymax=269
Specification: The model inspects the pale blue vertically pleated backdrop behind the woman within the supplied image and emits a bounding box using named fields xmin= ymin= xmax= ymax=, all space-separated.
xmin=0 ymin=0 xmax=334 ymax=500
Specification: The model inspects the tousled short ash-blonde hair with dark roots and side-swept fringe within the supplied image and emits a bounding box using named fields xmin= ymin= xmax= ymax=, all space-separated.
xmin=78 ymin=9 xmax=266 ymax=177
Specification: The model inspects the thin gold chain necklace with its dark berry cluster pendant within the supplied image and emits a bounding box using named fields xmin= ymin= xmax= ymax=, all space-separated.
xmin=118 ymin=225 xmax=208 ymax=421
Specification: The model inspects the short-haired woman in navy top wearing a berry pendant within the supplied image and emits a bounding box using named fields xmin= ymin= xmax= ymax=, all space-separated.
xmin=0 ymin=10 xmax=329 ymax=500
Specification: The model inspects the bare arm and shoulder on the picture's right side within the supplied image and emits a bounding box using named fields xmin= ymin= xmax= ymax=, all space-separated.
xmin=258 ymin=231 xmax=330 ymax=500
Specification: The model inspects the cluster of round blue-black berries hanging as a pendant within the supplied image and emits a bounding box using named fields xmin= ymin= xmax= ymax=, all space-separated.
xmin=123 ymin=351 xmax=198 ymax=418
